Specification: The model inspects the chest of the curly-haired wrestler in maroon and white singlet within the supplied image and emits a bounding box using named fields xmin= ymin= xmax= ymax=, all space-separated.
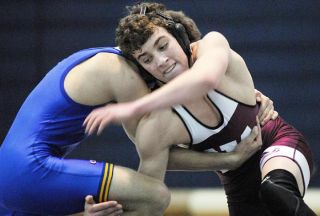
xmin=175 ymin=92 xmax=258 ymax=152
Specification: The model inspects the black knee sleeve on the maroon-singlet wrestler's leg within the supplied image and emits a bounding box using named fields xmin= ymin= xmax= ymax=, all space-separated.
xmin=260 ymin=169 xmax=316 ymax=216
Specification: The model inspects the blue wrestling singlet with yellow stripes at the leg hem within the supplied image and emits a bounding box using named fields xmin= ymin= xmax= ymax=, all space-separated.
xmin=0 ymin=48 xmax=121 ymax=215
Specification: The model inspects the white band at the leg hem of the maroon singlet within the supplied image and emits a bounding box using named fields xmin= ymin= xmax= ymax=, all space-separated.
xmin=260 ymin=146 xmax=310 ymax=193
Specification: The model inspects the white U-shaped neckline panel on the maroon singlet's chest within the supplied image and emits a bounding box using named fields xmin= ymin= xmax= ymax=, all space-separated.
xmin=174 ymin=90 xmax=238 ymax=145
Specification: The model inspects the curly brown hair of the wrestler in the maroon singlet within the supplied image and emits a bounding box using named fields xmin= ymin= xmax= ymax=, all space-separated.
xmin=116 ymin=2 xmax=201 ymax=56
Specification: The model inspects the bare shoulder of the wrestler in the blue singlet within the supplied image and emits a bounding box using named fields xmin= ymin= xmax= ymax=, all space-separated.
xmin=64 ymin=53 xmax=148 ymax=105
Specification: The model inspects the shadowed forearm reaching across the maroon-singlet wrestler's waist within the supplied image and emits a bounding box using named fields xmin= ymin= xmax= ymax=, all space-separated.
xmin=167 ymin=147 xmax=244 ymax=171
